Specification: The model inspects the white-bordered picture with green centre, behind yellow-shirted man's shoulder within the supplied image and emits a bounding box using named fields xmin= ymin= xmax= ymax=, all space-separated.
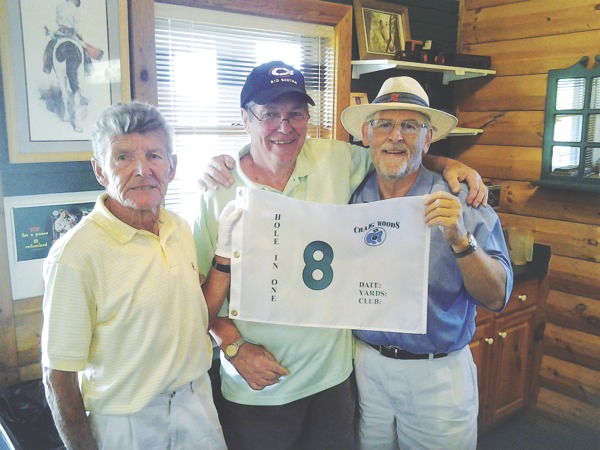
xmin=4 ymin=191 xmax=104 ymax=300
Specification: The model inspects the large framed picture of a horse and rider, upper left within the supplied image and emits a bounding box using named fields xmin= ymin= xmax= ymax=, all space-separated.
xmin=0 ymin=0 xmax=130 ymax=163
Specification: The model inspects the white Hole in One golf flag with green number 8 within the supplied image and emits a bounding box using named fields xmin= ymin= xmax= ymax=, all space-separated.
xmin=229 ymin=188 xmax=430 ymax=334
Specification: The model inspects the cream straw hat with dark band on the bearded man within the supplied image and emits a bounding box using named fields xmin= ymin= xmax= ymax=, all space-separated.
xmin=341 ymin=77 xmax=458 ymax=142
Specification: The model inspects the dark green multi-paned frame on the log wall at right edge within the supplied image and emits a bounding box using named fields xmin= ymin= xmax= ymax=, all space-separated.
xmin=540 ymin=57 xmax=600 ymax=191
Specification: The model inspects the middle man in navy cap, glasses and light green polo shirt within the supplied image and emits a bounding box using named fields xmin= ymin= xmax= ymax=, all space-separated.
xmin=194 ymin=61 xmax=492 ymax=450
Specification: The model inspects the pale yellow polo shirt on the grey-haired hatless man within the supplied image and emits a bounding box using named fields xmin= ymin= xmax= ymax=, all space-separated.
xmin=42 ymin=194 xmax=212 ymax=414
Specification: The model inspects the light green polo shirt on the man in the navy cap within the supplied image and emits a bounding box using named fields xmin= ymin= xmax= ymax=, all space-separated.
xmin=194 ymin=139 xmax=371 ymax=406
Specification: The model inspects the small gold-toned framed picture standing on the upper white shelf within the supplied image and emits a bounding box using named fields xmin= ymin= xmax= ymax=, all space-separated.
xmin=354 ymin=0 xmax=410 ymax=59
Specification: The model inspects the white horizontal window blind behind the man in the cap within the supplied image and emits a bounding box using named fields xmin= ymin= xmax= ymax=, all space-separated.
xmin=155 ymin=3 xmax=335 ymax=222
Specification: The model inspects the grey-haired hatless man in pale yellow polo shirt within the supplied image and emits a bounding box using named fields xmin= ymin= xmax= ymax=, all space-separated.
xmin=42 ymin=102 xmax=229 ymax=449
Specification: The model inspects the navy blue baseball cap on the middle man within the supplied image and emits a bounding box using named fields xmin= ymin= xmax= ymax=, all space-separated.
xmin=240 ymin=61 xmax=315 ymax=108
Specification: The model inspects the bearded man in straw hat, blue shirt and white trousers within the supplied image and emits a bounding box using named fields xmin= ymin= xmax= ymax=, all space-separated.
xmin=341 ymin=77 xmax=513 ymax=450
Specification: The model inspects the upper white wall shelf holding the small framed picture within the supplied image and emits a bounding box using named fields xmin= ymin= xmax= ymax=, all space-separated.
xmin=352 ymin=59 xmax=496 ymax=84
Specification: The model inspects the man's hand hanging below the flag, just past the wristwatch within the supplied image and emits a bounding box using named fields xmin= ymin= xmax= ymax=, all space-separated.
xmin=231 ymin=342 xmax=288 ymax=391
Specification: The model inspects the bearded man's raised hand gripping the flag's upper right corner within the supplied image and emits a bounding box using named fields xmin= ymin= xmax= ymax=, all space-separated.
xmin=425 ymin=191 xmax=469 ymax=246
